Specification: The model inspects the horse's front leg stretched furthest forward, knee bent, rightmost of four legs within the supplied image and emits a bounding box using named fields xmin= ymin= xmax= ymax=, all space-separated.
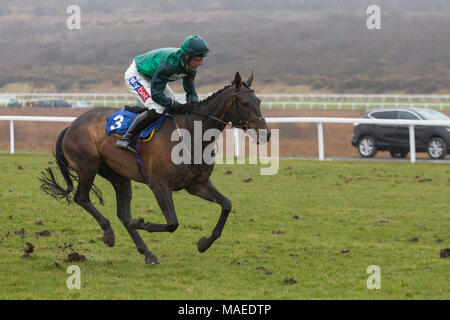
xmin=186 ymin=179 xmax=231 ymax=252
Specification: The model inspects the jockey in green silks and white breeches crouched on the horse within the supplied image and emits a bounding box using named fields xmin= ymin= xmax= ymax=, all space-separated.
xmin=116 ymin=35 xmax=210 ymax=154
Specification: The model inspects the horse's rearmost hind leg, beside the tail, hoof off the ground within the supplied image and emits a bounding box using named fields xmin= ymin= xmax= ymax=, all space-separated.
xmin=74 ymin=169 xmax=114 ymax=247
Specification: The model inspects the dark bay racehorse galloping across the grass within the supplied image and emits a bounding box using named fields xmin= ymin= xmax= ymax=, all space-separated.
xmin=40 ymin=72 xmax=270 ymax=264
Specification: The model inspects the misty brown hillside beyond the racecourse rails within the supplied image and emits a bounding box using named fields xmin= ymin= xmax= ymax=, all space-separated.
xmin=0 ymin=0 xmax=450 ymax=93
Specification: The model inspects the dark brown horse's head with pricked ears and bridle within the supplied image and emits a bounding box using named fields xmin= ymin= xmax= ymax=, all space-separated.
xmin=227 ymin=71 xmax=270 ymax=144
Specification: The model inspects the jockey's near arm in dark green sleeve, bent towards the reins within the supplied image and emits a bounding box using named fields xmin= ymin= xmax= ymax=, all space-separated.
xmin=151 ymin=62 xmax=179 ymax=109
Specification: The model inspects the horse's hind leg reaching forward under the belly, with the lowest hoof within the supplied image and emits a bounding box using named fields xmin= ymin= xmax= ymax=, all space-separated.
xmin=99 ymin=167 xmax=159 ymax=264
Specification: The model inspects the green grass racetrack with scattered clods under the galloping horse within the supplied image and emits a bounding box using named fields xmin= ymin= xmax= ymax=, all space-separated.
xmin=0 ymin=154 xmax=450 ymax=299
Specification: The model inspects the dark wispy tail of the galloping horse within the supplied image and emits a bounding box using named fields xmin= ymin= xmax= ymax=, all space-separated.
xmin=39 ymin=128 xmax=78 ymax=204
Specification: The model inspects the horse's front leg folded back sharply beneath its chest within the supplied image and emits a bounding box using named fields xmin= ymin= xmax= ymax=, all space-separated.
xmin=131 ymin=185 xmax=178 ymax=232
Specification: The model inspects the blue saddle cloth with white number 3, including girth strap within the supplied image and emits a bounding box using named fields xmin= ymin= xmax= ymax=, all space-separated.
xmin=106 ymin=109 xmax=166 ymax=184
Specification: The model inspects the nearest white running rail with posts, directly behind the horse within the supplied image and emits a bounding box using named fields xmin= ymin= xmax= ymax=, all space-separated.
xmin=0 ymin=116 xmax=450 ymax=163
